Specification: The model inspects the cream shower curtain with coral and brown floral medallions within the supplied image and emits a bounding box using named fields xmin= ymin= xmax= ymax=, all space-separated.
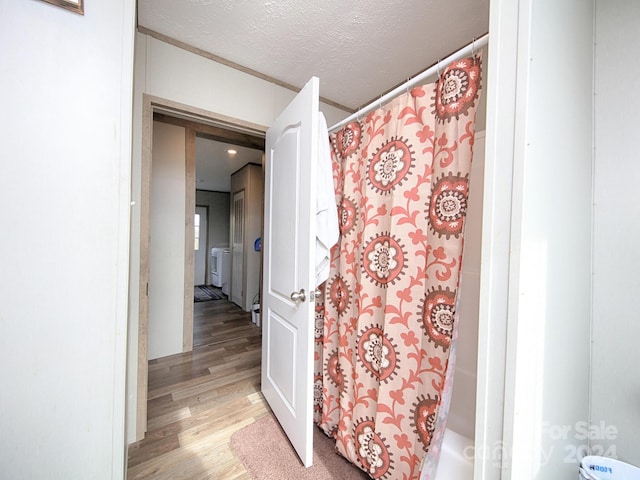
xmin=314 ymin=57 xmax=481 ymax=480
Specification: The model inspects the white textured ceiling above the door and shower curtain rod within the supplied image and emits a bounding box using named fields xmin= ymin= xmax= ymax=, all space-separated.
xmin=138 ymin=0 xmax=489 ymax=109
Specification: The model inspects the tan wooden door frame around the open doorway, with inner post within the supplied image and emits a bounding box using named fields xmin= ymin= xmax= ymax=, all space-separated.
xmin=135 ymin=94 xmax=267 ymax=441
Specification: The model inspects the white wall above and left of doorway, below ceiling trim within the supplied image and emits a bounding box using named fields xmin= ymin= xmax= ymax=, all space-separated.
xmin=127 ymin=33 xmax=347 ymax=442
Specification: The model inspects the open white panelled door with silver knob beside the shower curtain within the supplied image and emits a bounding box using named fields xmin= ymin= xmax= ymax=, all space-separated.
xmin=262 ymin=77 xmax=319 ymax=467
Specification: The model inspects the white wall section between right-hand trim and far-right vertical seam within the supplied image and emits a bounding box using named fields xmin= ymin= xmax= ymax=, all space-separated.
xmin=510 ymin=0 xmax=593 ymax=480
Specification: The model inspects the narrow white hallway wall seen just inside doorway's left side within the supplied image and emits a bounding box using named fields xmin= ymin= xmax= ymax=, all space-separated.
xmin=148 ymin=122 xmax=186 ymax=360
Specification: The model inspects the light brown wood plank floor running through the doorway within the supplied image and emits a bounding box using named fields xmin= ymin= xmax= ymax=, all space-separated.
xmin=127 ymin=300 xmax=270 ymax=480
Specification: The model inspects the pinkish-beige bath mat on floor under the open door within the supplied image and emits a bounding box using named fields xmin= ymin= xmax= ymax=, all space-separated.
xmin=231 ymin=415 xmax=369 ymax=480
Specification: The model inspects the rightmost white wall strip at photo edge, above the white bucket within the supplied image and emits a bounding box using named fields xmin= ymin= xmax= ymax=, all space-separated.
xmin=591 ymin=0 xmax=640 ymax=466
